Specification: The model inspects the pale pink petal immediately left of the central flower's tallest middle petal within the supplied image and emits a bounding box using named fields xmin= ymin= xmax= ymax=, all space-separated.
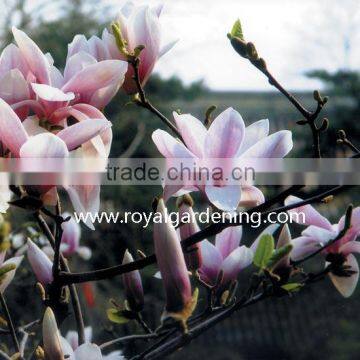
xmin=173 ymin=111 xmax=207 ymax=158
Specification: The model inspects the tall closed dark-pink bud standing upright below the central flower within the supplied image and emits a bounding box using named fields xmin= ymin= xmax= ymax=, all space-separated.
xmin=154 ymin=199 xmax=194 ymax=321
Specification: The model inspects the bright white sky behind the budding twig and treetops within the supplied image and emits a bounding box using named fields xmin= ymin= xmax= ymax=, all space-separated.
xmin=6 ymin=0 xmax=360 ymax=91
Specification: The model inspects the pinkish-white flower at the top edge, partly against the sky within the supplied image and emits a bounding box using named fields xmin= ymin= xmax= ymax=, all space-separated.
xmin=102 ymin=2 xmax=176 ymax=94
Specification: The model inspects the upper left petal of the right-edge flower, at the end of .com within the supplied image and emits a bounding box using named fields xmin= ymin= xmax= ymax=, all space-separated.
xmin=285 ymin=196 xmax=333 ymax=231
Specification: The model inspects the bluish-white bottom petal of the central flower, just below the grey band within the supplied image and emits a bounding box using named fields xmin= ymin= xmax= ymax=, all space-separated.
xmin=205 ymin=185 xmax=242 ymax=211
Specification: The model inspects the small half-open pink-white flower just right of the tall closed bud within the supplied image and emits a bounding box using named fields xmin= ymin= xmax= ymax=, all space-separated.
xmin=199 ymin=226 xmax=253 ymax=287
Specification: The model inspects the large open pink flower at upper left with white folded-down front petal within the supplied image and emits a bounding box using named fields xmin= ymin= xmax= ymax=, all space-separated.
xmin=7 ymin=28 xmax=127 ymax=124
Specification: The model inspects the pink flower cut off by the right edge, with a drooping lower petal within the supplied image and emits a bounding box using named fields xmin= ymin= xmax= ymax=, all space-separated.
xmin=285 ymin=196 xmax=360 ymax=297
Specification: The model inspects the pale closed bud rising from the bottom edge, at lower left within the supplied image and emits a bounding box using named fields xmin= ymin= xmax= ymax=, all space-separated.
xmin=42 ymin=307 xmax=64 ymax=360
